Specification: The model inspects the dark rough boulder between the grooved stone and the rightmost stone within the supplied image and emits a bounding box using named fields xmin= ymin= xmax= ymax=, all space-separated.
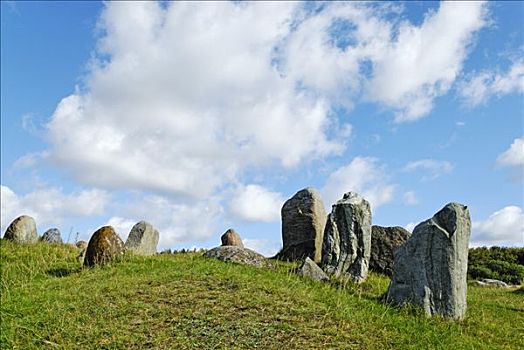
xmin=369 ymin=226 xmax=411 ymax=276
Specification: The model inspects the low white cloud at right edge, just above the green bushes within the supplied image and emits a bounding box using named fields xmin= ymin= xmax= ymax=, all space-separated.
xmin=471 ymin=206 xmax=524 ymax=246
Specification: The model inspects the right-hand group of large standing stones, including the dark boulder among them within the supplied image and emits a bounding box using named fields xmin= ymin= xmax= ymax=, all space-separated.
xmin=276 ymin=188 xmax=471 ymax=319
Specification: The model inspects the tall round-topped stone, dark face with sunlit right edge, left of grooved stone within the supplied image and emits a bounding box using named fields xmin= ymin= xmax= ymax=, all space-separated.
xmin=278 ymin=188 xmax=326 ymax=262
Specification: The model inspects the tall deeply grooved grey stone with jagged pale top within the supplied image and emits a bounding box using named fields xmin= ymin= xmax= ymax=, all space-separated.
xmin=321 ymin=192 xmax=371 ymax=283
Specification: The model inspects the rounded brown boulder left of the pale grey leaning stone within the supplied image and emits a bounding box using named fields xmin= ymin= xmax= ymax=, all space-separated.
xmin=84 ymin=226 xmax=125 ymax=267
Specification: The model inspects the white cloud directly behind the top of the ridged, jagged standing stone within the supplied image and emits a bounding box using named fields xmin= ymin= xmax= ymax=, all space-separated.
xmin=321 ymin=157 xmax=395 ymax=209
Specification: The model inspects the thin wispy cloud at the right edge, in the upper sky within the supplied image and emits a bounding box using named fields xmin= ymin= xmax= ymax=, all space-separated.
xmin=459 ymin=60 xmax=524 ymax=107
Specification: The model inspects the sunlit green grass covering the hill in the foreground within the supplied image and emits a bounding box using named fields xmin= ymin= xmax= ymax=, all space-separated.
xmin=0 ymin=241 xmax=524 ymax=349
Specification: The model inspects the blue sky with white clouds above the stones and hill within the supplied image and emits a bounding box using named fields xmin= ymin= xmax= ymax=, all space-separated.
xmin=1 ymin=1 xmax=524 ymax=254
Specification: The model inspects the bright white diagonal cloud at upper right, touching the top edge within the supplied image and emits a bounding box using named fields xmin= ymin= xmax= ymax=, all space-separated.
xmin=368 ymin=1 xmax=487 ymax=122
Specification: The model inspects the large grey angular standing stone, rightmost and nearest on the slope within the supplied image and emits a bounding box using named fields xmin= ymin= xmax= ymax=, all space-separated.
xmin=386 ymin=203 xmax=471 ymax=319
